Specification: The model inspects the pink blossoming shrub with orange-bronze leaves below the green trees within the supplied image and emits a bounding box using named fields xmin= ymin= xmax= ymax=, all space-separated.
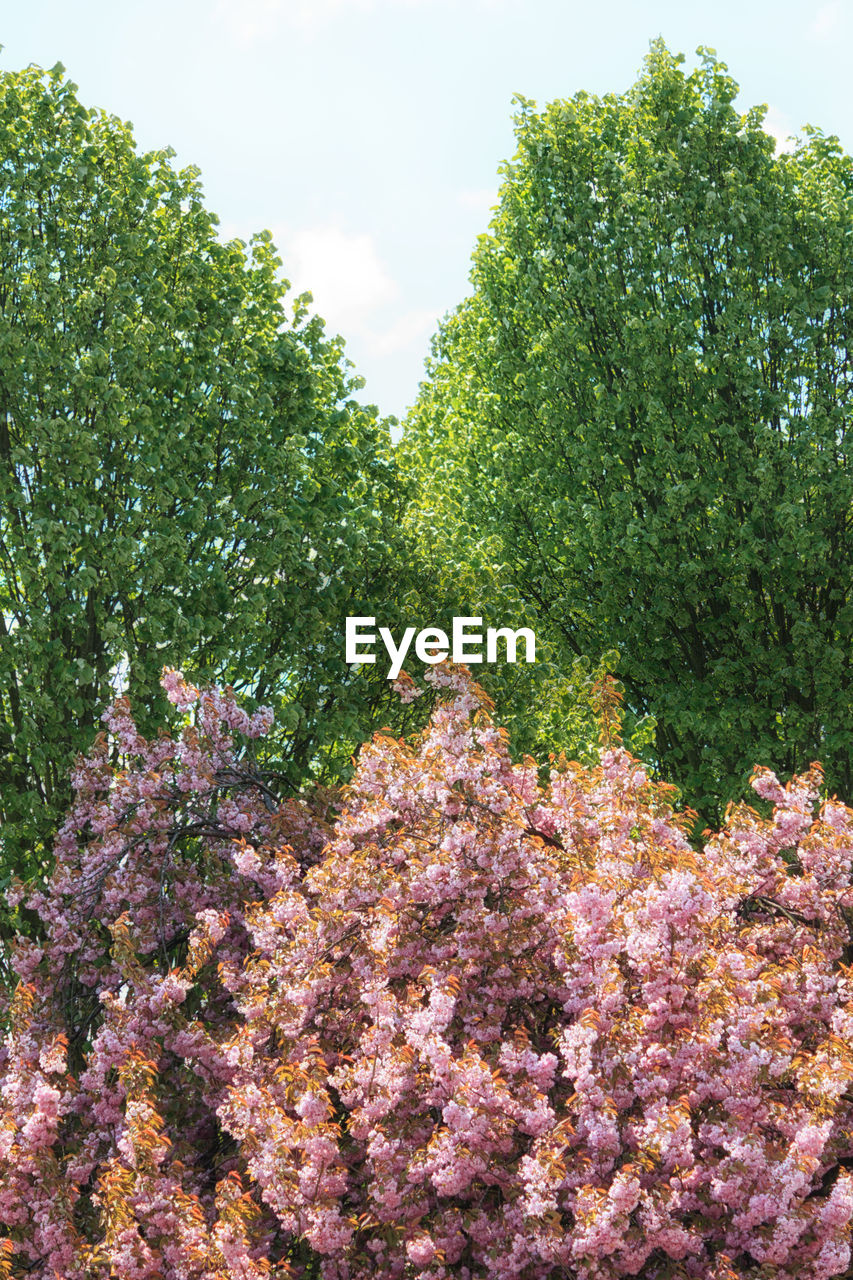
xmin=0 ymin=667 xmax=853 ymax=1280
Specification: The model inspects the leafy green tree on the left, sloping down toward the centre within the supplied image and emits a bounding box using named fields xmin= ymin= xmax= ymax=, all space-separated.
xmin=0 ymin=57 xmax=406 ymax=883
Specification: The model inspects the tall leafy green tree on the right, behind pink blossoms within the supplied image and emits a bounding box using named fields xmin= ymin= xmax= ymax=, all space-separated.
xmin=401 ymin=42 xmax=853 ymax=813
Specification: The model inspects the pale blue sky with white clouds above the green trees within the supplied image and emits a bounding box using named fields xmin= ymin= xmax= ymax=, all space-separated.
xmin=0 ymin=0 xmax=853 ymax=419
